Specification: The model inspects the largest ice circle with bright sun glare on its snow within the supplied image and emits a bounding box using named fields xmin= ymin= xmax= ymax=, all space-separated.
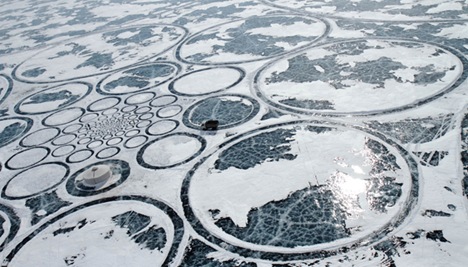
xmin=181 ymin=121 xmax=418 ymax=260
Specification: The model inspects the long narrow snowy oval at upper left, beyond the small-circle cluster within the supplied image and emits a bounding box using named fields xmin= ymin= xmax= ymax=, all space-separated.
xmin=13 ymin=25 xmax=187 ymax=83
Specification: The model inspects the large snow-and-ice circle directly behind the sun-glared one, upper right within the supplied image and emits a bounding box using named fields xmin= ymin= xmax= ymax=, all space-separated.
xmin=254 ymin=39 xmax=467 ymax=115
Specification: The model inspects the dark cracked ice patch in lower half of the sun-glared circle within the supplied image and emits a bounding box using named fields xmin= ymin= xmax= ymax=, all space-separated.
xmin=215 ymin=186 xmax=350 ymax=248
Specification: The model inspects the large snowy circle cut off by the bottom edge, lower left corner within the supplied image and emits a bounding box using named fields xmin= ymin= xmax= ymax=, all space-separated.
xmin=4 ymin=195 xmax=184 ymax=267
